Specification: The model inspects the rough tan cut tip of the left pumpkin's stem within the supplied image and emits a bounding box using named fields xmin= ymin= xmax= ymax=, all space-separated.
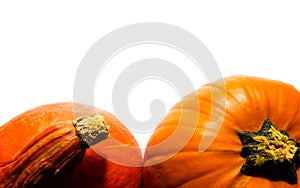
xmin=73 ymin=115 xmax=109 ymax=148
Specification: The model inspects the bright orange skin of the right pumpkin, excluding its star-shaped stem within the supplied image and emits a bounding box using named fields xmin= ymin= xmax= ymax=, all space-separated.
xmin=143 ymin=76 xmax=300 ymax=188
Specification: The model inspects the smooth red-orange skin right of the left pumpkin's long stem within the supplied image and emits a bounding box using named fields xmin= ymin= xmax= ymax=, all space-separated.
xmin=62 ymin=105 xmax=143 ymax=188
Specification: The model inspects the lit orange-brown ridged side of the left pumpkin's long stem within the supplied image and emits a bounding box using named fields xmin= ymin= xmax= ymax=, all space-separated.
xmin=3 ymin=126 xmax=84 ymax=187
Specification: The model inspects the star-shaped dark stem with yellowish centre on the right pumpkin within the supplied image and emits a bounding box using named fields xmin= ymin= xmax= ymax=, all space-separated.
xmin=238 ymin=119 xmax=300 ymax=184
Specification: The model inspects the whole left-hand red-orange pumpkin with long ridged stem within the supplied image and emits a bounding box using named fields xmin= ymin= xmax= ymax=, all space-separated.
xmin=0 ymin=103 xmax=142 ymax=187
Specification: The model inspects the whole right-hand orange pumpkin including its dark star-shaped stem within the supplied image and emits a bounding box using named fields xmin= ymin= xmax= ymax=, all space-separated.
xmin=143 ymin=75 xmax=300 ymax=187
